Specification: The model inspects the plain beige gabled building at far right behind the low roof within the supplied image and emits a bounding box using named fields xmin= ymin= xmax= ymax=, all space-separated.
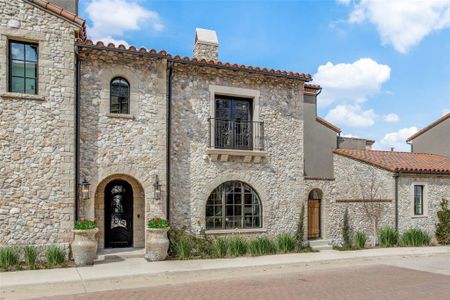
xmin=406 ymin=113 xmax=450 ymax=157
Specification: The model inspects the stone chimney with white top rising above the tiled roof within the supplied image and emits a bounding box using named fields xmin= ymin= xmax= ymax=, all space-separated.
xmin=194 ymin=28 xmax=219 ymax=62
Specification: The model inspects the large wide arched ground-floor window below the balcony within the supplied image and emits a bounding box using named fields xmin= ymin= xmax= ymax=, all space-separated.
xmin=206 ymin=181 xmax=262 ymax=230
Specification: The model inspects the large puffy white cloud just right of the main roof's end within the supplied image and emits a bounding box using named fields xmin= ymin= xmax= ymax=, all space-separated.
xmin=314 ymin=58 xmax=391 ymax=106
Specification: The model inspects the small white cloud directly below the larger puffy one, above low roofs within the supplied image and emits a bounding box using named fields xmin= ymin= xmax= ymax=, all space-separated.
xmin=325 ymin=104 xmax=377 ymax=127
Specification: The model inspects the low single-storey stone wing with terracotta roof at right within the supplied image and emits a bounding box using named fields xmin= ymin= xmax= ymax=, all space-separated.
xmin=328 ymin=149 xmax=450 ymax=245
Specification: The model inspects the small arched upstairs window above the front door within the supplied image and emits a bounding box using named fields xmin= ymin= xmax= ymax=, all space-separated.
xmin=110 ymin=77 xmax=130 ymax=114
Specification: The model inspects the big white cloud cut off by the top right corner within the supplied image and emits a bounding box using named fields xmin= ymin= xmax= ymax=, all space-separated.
xmin=338 ymin=0 xmax=450 ymax=53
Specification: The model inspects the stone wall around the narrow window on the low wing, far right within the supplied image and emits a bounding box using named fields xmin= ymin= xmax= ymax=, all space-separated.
xmin=398 ymin=175 xmax=450 ymax=235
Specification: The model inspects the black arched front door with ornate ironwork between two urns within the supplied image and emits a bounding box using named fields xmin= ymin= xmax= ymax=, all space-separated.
xmin=104 ymin=179 xmax=133 ymax=248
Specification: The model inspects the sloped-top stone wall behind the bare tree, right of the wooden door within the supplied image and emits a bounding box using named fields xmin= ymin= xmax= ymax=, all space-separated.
xmin=327 ymin=154 xmax=395 ymax=244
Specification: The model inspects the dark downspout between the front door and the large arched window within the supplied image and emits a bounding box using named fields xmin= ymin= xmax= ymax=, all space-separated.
xmin=166 ymin=61 xmax=173 ymax=222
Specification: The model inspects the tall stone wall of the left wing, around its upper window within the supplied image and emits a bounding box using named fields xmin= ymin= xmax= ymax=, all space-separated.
xmin=0 ymin=0 xmax=79 ymax=247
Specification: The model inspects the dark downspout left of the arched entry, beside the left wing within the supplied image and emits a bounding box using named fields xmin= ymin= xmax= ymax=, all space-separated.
xmin=75 ymin=46 xmax=80 ymax=221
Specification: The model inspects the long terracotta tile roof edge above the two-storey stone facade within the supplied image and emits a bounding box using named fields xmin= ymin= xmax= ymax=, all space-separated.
xmin=77 ymin=39 xmax=312 ymax=81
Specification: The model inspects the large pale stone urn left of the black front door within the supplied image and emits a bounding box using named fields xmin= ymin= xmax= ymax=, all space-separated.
xmin=70 ymin=228 xmax=98 ymax=266
